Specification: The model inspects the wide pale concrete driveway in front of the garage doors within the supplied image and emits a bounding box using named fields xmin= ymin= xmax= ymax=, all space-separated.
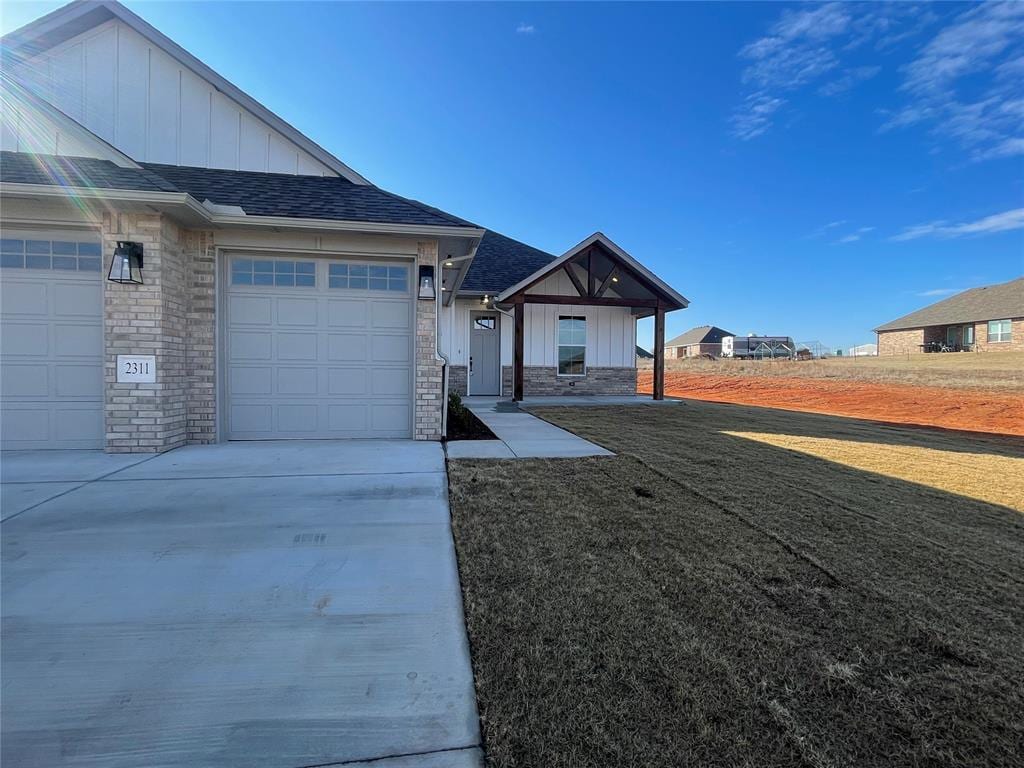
xmin=0 ymin=440 xmax=481 ymax=768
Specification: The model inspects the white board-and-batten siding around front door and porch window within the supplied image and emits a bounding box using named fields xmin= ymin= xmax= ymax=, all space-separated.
xmin=441 ymin=296 xmax=636 ymax=368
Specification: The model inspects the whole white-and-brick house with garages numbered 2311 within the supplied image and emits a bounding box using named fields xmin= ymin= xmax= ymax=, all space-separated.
xmin=0 ymin=0 xmax=687 ymax=452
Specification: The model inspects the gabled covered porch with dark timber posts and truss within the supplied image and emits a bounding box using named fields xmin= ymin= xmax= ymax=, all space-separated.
xmin=492 ymin=232 xmax=689 ymax=401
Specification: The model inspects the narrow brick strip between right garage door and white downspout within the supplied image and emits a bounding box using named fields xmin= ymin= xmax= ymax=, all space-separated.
xmin=413 ymin=241 xmax=443 ymax=440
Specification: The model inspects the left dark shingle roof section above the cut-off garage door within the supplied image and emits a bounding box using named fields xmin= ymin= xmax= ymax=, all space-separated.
xmin=0 ymin=152 xmax=179 ymax=193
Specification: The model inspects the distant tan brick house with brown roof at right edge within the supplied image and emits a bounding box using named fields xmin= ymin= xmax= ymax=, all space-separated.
xmin=874 ymin=276 xmax=1024 ymax=354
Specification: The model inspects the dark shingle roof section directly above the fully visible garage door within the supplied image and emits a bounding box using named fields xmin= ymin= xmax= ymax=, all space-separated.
xmin=143 ymin=163 xmax=475 ymax=226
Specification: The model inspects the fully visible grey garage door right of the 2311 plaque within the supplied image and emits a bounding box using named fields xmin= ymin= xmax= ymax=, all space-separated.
xmin=226 ymin=256 xmax=414 ymax=440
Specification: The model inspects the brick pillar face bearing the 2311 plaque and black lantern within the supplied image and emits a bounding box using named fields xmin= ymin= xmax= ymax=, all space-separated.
xmin=102 ymin=213 xmax=188 ymax=453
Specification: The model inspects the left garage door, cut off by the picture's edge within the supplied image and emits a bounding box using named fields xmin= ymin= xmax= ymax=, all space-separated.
xmin=0 ymin=231 xmax=103 ymax=449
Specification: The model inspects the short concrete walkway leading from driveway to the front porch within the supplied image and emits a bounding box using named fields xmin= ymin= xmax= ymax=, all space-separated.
xmin=447 ymin=397 xmax=614 ymax=459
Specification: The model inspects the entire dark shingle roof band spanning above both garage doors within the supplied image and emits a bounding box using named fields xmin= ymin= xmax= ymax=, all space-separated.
xmin=0 ymin=152 xmax=475 ymax=227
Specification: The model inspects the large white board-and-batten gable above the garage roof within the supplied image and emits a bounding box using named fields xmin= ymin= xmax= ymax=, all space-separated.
xmin=3 ymin=2 xmax=369 ymax=183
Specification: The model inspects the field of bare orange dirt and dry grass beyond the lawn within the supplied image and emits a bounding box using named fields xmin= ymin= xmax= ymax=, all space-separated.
xmin=637 ymin=352 xmax=1024 ymax=436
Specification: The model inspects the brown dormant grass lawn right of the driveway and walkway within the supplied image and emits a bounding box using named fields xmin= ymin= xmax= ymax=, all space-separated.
xmin=450 ymin=402 xmax=1024 ymax=768
